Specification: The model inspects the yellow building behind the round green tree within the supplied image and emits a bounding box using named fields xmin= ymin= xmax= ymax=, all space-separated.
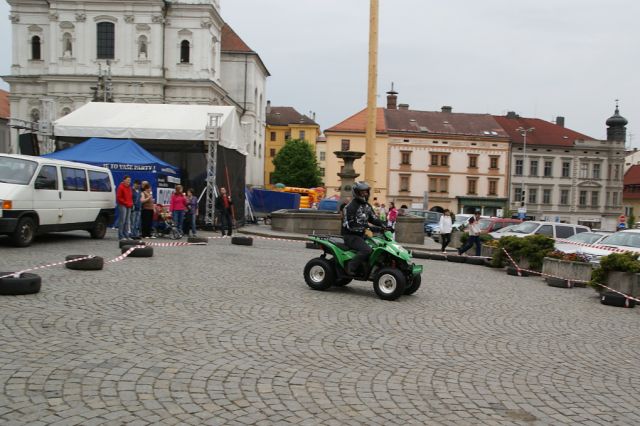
xmin=264 ymin=101 xmax=320 ymax=185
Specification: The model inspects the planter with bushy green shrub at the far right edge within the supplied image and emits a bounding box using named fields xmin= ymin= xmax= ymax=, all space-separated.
xmin=589 ymin=252 xmax=640 ymax=297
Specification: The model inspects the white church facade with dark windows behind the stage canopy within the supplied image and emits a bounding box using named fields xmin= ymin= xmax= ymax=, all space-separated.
xmin=4 ymin=0 xmax=269 ymax=184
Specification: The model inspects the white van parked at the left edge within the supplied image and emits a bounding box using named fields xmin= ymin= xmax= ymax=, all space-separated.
xmin=0 ymin=154 xmax=115 ymax=247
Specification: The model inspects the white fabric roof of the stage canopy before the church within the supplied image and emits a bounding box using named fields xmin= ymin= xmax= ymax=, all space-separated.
xmin=53 ymin=102 xmax=247 ymax=155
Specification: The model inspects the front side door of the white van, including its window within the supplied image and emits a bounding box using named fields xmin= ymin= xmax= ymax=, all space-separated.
xmin=33 ymin=165 xmax=62 ymax=226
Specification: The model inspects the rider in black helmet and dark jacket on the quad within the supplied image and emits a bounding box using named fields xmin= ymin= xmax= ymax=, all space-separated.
xmin=342 ymin=182 xmax=384 ymax=275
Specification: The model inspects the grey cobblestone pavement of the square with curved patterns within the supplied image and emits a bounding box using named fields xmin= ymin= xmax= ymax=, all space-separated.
xmin=0 ymin=233 xmax=640 ymax=425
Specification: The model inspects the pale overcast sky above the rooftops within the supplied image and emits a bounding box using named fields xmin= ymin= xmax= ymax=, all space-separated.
xmin=0 ymin=0 xmax=640 ymax=147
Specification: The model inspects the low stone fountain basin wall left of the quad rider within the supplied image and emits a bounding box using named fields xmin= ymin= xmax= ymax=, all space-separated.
xmin=271 ymin=210 xmax=341 ymax=235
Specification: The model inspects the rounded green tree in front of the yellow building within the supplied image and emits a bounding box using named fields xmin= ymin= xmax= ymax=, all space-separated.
xmin=273 ymin=139 xmax=321 ymax=188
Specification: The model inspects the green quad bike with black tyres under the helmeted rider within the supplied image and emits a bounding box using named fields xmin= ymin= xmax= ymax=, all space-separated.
xmin=304 ymin=227 xmax=422 ymax=300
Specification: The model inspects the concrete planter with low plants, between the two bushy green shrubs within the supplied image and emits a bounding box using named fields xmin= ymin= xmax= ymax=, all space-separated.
xmin=542 ymin=250 xmax=592 ymax=288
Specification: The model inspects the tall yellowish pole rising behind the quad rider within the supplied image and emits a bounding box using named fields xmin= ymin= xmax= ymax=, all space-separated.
xmin=364 ymin=0 xmax=378 ymax=188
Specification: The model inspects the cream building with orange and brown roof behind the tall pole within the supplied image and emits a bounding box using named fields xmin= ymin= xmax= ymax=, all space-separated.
xmin=325 ymin=92 xmax=509 ymax=215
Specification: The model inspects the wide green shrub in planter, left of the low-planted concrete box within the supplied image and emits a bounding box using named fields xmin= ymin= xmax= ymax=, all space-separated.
xmin=491 ymin=235 xmax=554 ymax=271
